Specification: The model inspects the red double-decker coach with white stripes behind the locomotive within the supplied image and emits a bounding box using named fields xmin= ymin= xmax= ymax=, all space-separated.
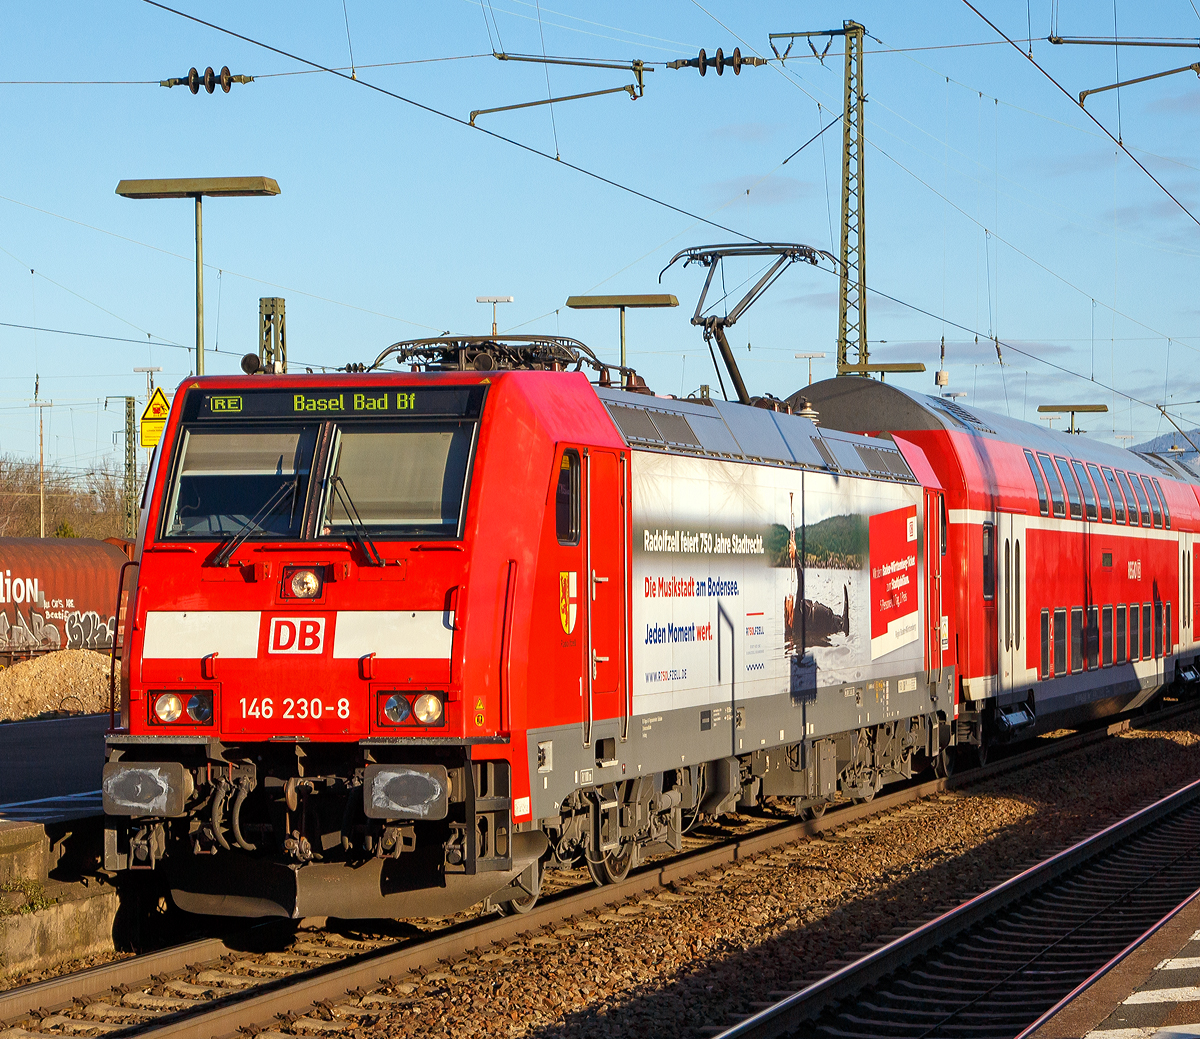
xmin=805 ymin=379 xmax=1200 ymax=755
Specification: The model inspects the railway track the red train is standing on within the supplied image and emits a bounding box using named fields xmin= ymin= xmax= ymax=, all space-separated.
xmin=0 ymin=703 xmax=1198 ymax=1039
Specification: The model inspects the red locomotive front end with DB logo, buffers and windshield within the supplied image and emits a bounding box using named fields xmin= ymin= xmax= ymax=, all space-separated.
xmin=103 ymin=377 xmax=544 ymax=917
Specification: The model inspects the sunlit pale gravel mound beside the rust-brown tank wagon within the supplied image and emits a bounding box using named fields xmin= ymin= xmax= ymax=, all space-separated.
xmin=0 ymin=649 xmax=120 ymax=721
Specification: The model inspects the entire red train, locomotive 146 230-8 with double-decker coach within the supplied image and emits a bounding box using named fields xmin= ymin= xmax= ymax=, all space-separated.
xmin=103 ymin=337 xmax=1200 ymax=917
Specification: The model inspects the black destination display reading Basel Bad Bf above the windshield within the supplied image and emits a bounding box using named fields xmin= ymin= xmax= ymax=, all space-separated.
xmin=184 ymin=385 xmax=485 ymax=421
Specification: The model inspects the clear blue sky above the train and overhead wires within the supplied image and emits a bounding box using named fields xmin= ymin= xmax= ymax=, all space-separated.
xmin=0 ymin=0 xmax=1200 ymax=472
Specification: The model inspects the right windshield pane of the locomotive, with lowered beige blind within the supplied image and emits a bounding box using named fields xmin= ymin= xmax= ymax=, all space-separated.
xmin=320 ymin=422 xmax=474 ymax=537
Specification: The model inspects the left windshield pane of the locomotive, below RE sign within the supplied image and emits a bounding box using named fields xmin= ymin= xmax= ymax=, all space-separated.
xmin=163 ymin=426 xmax=317 ymax=539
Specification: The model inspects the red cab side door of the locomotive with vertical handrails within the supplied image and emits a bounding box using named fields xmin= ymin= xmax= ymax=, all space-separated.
xmin=580 ymin=449 xmax=629 ymax=745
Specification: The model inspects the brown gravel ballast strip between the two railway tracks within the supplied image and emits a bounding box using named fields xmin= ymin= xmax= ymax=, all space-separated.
xmin=350 ymin=722 xmax=1200 ymax=1039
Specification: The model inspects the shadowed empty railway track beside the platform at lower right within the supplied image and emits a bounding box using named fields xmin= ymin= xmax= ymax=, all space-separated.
xmin=719 ymin=758 xmax=1200 ymax=1039
